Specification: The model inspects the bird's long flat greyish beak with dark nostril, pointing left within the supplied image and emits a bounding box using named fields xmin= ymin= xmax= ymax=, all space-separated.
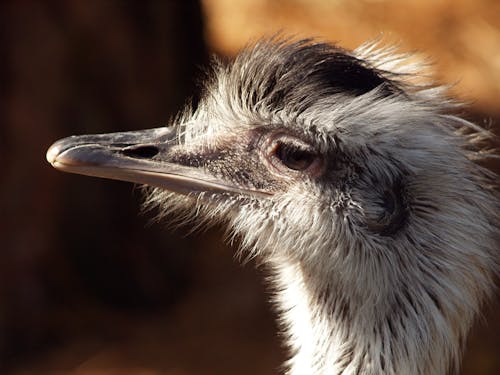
xmin=47 ymin=128 xmax=271 ymax=197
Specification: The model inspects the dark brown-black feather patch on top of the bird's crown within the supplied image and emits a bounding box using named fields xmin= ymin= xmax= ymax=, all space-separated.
xmin=222 ymin=39 xmax=401 ymax=113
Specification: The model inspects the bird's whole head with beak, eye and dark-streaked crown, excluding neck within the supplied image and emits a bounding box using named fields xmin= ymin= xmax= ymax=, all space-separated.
xmin=47 ymin=42 xmax=496 ymax=272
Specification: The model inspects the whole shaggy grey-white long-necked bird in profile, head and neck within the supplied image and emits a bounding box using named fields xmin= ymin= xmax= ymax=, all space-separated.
xmin=47 ymin=38 xmax=500 ymax=375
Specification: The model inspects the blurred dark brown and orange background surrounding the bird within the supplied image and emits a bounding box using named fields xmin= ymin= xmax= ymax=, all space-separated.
xmin=0 ymin=0 xmax=500 ymax=375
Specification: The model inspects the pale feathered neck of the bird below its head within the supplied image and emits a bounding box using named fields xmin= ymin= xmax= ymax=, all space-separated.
xmin=272 ymin=260 xmax=460 ymax=375
